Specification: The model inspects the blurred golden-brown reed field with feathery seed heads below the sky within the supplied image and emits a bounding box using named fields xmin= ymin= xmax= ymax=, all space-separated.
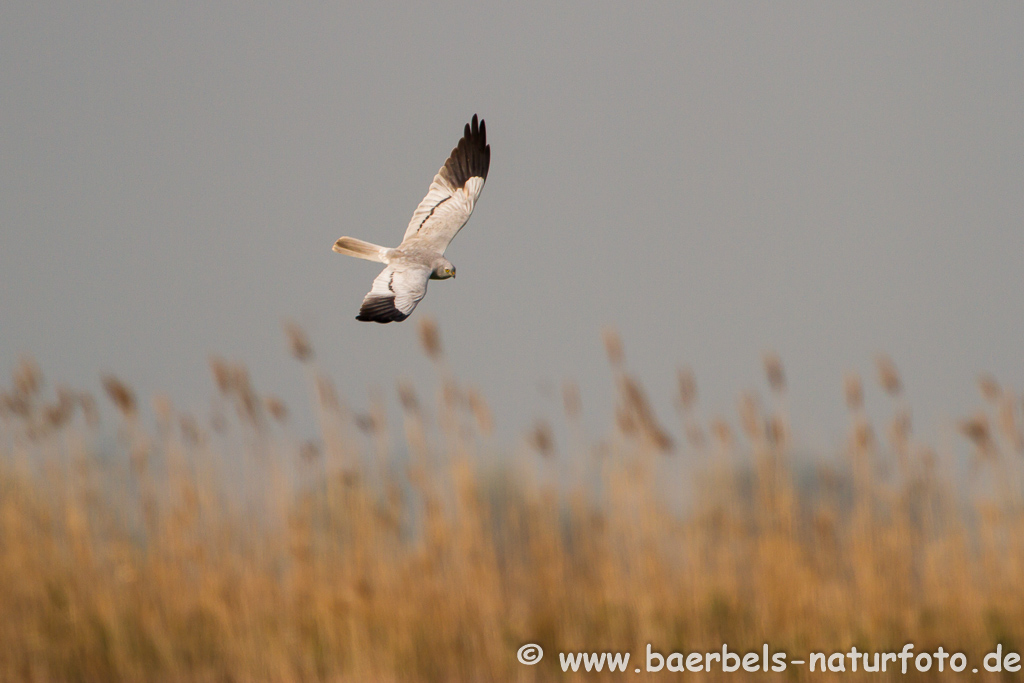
xmin=0 ymin=321 xmax=1024 ymax=682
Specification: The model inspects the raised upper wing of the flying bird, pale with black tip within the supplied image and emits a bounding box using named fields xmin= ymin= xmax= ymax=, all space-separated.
xmin=398 ymin=114 xmax=490 ymax=254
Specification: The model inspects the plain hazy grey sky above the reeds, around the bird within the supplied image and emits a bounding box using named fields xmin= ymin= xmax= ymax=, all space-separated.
xmin=0 ymin=2 xmax=1024 ymax=444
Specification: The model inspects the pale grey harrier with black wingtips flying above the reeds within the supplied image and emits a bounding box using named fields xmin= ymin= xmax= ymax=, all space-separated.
xmin=334 ymin=114 xmax=490 ymax=323
